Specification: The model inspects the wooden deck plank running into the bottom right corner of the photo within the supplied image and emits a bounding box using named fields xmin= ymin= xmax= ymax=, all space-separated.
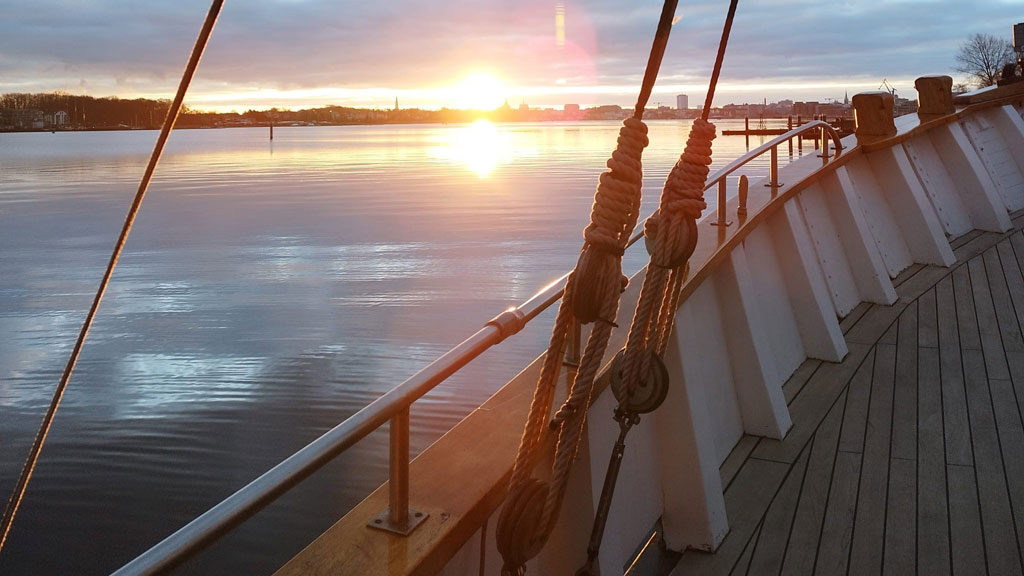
xmin=964 ymin=349 xmax=1021 ymax=574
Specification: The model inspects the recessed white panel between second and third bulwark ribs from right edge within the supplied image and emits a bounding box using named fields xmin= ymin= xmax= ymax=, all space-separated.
xmin=903 ymin=133 xmax=975 ymax=238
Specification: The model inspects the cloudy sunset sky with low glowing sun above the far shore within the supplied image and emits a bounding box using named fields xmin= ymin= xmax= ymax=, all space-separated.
xmin=0 ymin=0 xmax=1024 ymax=111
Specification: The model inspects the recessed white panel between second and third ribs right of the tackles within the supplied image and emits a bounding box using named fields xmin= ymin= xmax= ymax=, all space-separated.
xmin=742 ymin=225 xmax=807 ymax=382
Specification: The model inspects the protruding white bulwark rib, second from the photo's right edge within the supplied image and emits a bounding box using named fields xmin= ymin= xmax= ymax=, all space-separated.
xmin=926 ymin=123 xmax=1010 ymax=232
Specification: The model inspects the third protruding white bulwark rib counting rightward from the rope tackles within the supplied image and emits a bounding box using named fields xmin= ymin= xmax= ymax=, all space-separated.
xmin=767 ymin=200 xmax=847 ymax=362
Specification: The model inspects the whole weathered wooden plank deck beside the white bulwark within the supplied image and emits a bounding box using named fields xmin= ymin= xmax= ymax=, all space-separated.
xmin=672 ymin=211 xmax=1024 ymax=576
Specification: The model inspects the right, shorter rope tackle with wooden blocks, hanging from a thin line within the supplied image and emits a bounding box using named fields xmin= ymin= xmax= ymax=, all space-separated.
xmin=618 ymin=0 xmax=738 ymax=420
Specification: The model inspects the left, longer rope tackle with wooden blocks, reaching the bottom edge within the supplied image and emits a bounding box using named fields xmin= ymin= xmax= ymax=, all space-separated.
xmin=496 ymin=0 xmax=678 ymax=576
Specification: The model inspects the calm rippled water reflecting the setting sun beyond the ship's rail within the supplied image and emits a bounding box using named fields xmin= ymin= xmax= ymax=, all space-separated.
xmin=0 ymin=121 xmax=794 ymax=574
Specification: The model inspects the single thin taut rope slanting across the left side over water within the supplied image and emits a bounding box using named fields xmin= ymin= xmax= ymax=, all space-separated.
xmin=0 ymin=0 xmax=224 ymax=549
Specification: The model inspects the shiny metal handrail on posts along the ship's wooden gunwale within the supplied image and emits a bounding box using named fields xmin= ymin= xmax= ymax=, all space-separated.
xmin=114 ymin=121 xmax=842 ymax=576
